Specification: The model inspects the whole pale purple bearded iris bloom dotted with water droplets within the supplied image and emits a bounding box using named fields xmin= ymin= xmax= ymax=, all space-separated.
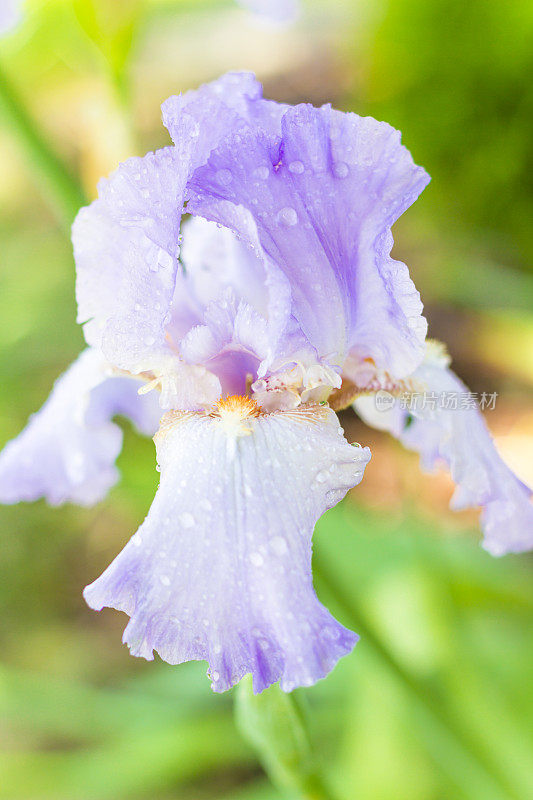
xmin=0 ymin=73 xmax=533 ymax=691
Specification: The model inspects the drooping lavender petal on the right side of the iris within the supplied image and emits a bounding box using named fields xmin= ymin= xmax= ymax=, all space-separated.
xmin=354 ymin=348 xmax=533 ymax=555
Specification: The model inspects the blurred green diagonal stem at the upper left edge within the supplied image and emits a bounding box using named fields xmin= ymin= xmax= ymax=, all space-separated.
xmin=0 ymin=59 xmax=88 ymax=229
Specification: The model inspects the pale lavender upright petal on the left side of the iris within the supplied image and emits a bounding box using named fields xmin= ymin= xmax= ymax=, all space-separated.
xmin=72 ymin=147 xmax=185 ymax=373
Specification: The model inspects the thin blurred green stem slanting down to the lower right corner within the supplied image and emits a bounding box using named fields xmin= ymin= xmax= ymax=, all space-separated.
xmin=313 ymin=556 xmax=518 ymax=800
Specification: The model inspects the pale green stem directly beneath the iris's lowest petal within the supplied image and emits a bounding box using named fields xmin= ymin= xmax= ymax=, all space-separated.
xmin=235 ymin=676 xmax=333 ymax=800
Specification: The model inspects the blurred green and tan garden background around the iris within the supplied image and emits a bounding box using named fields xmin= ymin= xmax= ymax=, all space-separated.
xmin=0 ymin=0 xmax=533 ymax=800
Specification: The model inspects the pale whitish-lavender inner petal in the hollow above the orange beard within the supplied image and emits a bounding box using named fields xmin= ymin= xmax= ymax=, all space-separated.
xmin=174 ymin=216 xmax=291 ymax=384
